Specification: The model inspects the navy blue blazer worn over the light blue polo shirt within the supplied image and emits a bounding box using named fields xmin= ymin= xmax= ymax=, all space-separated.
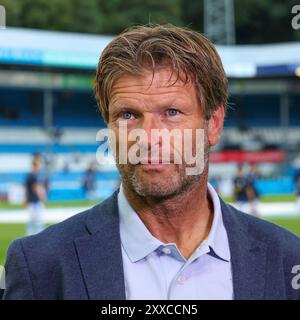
xmin=3 ymin=192 xmax=300 ymax=300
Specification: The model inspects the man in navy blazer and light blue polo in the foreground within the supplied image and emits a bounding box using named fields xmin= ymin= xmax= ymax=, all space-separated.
xmin=4 ymin=26 xmax=300 ymax=300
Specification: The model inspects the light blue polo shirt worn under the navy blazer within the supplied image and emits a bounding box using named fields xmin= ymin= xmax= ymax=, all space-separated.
xmin=118 ymin=184 xmax=233 ymax=300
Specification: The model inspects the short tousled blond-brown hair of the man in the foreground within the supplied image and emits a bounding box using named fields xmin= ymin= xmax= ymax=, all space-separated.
xmin=94 ymin=25 xmax=228 ymax=122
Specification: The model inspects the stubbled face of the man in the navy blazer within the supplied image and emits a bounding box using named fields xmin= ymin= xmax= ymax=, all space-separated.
xmin=108 ymin=68 xmax=220 ymax=198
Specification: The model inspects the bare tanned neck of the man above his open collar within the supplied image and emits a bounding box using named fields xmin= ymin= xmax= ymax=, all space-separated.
xmin=124 ymin=180 xmax=213 ymax=259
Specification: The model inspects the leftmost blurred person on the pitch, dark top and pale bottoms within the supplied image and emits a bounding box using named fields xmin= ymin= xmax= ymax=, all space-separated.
xmin=25 ymin=158 xmax=46 ymax=235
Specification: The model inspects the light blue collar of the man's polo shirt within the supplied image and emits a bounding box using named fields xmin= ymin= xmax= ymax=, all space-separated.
xmin=118 ymin=184 xmax=230 ymax=262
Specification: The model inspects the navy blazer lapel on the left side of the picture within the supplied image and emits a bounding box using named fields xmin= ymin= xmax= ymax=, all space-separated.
xmin=74 ymin=192 xmax=126 ymax=300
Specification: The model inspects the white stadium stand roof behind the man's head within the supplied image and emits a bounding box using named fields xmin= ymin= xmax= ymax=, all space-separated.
xmin=0 ymin=27 xmax=300 ymax=78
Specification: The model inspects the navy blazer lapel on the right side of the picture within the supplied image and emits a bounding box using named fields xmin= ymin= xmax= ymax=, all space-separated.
xmin=221 ymin=200 xmax=267 ymax=300
